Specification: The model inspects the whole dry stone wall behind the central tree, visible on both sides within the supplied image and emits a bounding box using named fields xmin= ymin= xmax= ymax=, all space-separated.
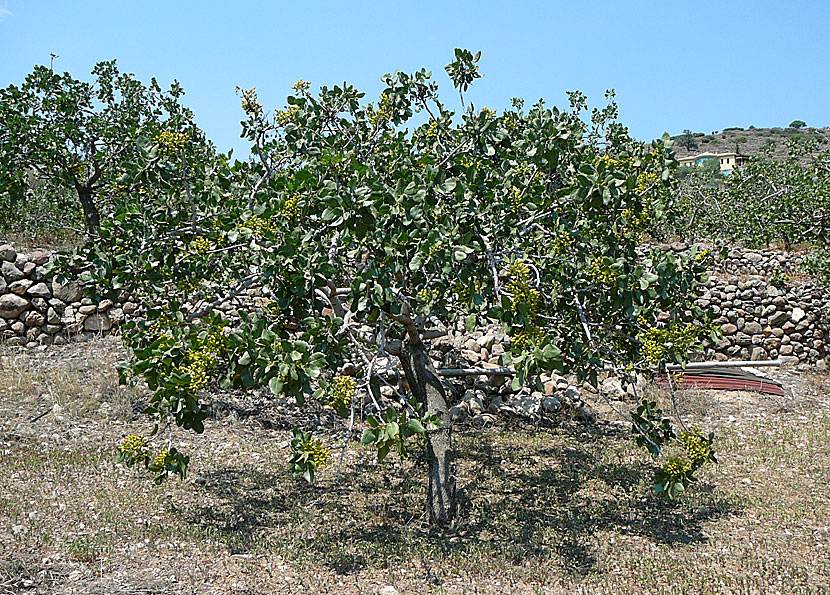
xmin=0 ymin=244 xmax=830 ymax=367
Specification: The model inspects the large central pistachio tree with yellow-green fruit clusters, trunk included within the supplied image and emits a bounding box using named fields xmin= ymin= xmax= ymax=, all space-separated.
xmin=67 ymin=50 xmax=713 ymax=525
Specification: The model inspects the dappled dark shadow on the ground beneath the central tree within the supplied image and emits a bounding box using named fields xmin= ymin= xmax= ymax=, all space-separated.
xmin=182 ymin=425 xmax=740 ymax=575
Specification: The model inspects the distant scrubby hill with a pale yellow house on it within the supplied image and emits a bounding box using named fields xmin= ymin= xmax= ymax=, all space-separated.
xmin=672 ymin=126 xmax=830 ymax=159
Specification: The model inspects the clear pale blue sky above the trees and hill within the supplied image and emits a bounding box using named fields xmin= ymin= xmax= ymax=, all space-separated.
xmin=0 ymin=0 xmax=830 ymax=155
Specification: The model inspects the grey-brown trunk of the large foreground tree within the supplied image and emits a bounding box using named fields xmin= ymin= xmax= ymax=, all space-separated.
xmin=400 ymin=340 xmax=456 ymax=527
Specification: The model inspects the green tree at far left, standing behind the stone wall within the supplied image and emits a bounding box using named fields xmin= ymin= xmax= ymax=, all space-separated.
xmin=0 ymin=57 xmax=209 ymax=233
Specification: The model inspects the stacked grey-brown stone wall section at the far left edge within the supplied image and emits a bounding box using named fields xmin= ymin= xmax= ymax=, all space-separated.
xmin=0 ymin=244 xmax=137 ymax=347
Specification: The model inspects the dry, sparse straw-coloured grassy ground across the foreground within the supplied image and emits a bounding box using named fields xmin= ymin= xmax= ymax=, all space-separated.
xmin=0 ymin=341 xmax=830 ymax=594
